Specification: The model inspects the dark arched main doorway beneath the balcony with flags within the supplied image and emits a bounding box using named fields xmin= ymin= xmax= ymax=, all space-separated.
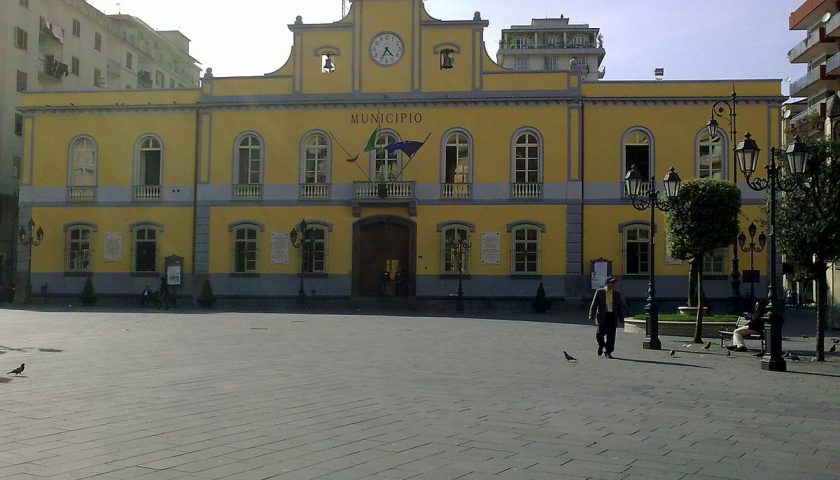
xmin=352 ymin=215 xmax=417 ymax=297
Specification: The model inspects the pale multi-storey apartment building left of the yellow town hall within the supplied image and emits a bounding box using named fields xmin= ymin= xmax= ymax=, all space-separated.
xmin=0 ymin=0 xmax=200 ymax=283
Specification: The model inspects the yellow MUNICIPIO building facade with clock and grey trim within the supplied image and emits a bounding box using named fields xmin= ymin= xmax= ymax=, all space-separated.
xmin=17 ymin=0 xmax=782 ymax=306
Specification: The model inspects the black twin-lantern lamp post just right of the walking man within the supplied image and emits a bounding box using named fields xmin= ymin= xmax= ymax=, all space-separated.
xmin=624 ymin=165 xmax=681 ymax=350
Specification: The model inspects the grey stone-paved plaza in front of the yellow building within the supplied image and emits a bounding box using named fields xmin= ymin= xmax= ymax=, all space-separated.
xmin=0 ymin=305 xmax=840 ymax=480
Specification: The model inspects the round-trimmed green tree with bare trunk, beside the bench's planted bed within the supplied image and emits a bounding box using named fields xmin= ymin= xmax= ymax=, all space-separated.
xmin=665 ymin=178 xmax=741 ymax=343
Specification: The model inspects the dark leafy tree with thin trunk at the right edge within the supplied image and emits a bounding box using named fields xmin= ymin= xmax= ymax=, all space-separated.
xmin=776 ymin=140 xmax=840 ymax=362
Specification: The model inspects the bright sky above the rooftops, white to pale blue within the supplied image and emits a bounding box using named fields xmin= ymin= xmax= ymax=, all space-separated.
xmin=88 ymin=0 xmax=806 ymax=93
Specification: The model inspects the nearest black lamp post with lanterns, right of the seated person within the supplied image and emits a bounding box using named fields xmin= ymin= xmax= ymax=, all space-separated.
xmin=735 ymin=133 xmax=808 ymax=372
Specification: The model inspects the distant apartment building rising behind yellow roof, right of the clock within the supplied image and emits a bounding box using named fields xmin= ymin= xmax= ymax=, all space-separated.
xmin=496 ymin=15 xmax=606 ymax=82
